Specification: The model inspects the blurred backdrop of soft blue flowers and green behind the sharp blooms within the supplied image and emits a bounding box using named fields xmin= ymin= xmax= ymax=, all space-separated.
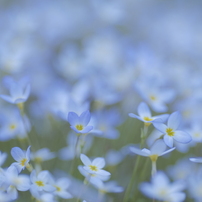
xmin=0 ymin=0 xmax=202 ymax=202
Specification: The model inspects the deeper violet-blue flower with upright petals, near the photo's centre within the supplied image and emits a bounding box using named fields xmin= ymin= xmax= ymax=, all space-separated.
xmin=68 ymin=110 xmax=93 ymax=133
